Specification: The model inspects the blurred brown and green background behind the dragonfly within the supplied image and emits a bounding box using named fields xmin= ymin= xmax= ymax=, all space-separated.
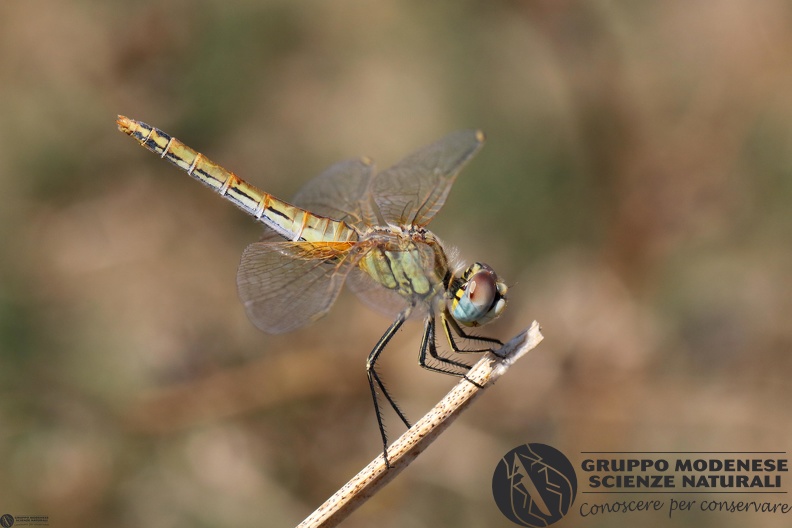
xmin=0 ymin=0 xmax=792 ymax=528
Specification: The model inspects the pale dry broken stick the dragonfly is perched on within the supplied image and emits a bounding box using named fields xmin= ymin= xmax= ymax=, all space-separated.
xmin=297 ymin=321 xmax=542 ymax=528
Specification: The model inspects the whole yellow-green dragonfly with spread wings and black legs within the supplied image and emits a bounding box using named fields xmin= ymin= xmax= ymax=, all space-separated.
xmin=117 ymin=116 xmax=507 ymax=467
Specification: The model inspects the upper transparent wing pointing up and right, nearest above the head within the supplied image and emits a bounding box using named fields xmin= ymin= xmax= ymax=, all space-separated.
xmin=371 ymin=130 xmax=484 ymax=226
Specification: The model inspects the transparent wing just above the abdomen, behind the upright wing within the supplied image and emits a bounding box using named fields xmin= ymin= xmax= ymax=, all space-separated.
xmin=293 ymin=159 xmax=376 ymax=226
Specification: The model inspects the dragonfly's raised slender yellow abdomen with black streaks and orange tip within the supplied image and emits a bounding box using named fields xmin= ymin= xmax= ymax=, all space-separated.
xmin=117 ymin=116 xmax=357 ymax=242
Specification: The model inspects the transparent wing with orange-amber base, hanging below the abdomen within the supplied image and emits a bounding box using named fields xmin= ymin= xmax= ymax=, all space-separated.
xmin=237 ymin=233 xmax=354 ymax=334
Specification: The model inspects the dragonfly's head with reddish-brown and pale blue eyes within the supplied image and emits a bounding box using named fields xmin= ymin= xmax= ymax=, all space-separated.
xmin=448 ymin=262 xmax=507 ymax=326
